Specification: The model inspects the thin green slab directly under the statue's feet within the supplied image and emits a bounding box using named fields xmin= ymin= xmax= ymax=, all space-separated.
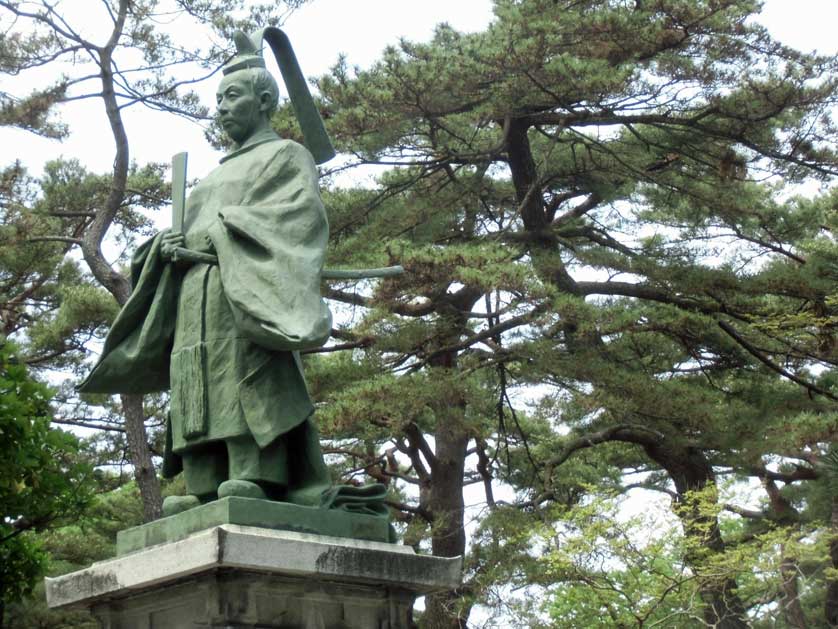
xmin=116 ymin=496 xmax=389 ymax=557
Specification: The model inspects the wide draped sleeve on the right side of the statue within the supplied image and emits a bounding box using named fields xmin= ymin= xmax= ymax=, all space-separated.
xmin=208 ymin=140 xmax=332 ymax=351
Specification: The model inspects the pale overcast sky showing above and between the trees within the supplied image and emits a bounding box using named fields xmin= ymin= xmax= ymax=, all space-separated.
xmin=0 ymin=0 xmax=838 ymax=184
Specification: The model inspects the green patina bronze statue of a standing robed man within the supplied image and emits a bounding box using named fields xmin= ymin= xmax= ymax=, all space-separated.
xmin=80 ymin=29 xmax=386 ymax=517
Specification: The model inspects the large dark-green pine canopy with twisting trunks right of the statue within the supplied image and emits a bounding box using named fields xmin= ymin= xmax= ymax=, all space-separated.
xmin=308 ymin=0 xmax=838 ymax=627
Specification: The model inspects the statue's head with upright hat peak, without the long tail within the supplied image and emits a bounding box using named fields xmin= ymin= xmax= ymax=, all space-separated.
xmin=216 ymin=32 xmax=279 ymax=145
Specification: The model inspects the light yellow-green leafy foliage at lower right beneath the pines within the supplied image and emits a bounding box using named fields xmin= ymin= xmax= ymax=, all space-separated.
xmin=471 ymin=486 xmax=825 ymax=628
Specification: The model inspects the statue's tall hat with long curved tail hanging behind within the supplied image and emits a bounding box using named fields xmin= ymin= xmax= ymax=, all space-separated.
xmin=226 ymin=26 xmax=335 ymax=164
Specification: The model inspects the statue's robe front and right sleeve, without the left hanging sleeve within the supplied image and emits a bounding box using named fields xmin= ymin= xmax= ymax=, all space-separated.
xmin=171 ymin=133 xmax=331 ymax=452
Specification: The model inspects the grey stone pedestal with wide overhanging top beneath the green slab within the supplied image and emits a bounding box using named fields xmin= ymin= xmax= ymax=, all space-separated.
xmin=47 ymin=524 xmax=461 ymax=629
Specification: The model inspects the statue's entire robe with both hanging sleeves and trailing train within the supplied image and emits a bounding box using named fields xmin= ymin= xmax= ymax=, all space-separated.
xmin=79 ymin=131 xmax=386 ymax=515
